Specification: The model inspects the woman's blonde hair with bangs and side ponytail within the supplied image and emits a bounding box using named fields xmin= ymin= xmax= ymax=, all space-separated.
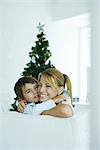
xmin=38 ymin=68 xmax=72 ymax=103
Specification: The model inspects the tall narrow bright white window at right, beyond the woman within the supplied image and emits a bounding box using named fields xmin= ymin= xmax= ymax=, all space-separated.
xmin=80 ymin=26 xmax=91 ymax=103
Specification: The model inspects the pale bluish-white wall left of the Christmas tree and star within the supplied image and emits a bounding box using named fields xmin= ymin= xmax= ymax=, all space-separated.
xmin=0 ymin=0 xmax=52 ymax=99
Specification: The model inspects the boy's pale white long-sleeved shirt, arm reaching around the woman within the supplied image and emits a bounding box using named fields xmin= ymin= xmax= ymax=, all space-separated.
xmin=23 ymin=99 xmax=56 ymax=115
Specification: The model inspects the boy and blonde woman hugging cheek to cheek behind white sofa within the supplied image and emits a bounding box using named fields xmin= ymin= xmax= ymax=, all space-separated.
xmin=14 ymin=68 xmax=73 ymax=118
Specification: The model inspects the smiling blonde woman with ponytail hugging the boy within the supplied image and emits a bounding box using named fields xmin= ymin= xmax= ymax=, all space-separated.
xmin=18 ymin=68 xmax=73 ymax=117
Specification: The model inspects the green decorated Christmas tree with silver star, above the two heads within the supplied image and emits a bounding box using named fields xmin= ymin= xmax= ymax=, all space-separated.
xmin=22 ymin=23 xmax=54 ymax=78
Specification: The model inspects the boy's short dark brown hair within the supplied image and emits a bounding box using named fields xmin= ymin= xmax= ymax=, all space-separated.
xmin=14 ymin=77 xmax=38 ymax=99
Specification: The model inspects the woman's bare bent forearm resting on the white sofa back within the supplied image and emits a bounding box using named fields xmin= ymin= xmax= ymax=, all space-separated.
xmin=41 ymin=104 xmax=73 ymax=118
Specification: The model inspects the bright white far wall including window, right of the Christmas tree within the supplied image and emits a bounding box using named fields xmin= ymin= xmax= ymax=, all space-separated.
xmin=50 ymin=13 xmax=90 ymax=104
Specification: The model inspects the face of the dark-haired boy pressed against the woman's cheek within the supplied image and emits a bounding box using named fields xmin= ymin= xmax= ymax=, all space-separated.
xmin=22 ymin=83 xmax=39 ymax=102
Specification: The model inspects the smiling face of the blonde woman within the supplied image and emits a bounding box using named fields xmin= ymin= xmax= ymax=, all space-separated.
xmin=38 ymin=76 xmax=58 ymax=101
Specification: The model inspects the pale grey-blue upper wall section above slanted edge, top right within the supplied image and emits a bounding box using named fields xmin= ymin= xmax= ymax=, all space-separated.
xmin=52 ymin=0 xmax=89 ymax=20
